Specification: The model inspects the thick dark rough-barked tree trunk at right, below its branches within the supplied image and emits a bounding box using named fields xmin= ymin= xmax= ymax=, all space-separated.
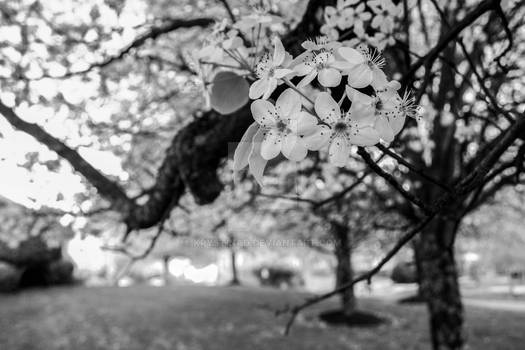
xmin=416 ymin=217 xmax=464 ymax=350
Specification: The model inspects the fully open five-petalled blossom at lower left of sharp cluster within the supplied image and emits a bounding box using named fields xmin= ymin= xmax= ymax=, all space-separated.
xmin=251 ymin=89 xmax=320 ymax=161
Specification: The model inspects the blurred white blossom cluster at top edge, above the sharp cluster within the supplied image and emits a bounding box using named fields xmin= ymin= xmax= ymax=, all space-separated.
xmin=321 ymin=0 xmax=403 ymax=50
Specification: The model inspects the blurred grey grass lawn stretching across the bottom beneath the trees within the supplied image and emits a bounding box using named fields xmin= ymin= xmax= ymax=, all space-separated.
xmin=0 ymin=286 xmax=525 ymax=350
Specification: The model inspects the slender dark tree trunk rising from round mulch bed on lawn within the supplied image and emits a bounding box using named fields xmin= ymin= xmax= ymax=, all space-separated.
xmin=332 ymin=223 xmax=356 ymax=315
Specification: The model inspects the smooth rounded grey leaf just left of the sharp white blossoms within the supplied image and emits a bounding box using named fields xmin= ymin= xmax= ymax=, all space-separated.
xmin=210 ymin=71 xmax=250 ymax=114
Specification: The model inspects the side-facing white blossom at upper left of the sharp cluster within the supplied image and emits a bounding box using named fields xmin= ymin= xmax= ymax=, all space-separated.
xmin=249 ymin=37 xmax=293 ymax=100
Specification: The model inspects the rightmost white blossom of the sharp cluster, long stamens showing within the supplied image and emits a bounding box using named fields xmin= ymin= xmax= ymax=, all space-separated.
xmin=346 ymin=81 xmax=405 ymax=143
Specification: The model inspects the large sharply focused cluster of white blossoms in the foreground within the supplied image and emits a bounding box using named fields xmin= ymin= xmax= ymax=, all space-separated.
xmin=250 ymin=38 xmax=417 ymax=166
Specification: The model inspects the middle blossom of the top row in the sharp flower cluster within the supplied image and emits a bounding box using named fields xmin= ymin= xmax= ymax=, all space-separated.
xmin=294 ymin=50 xmax=342 ymax=87
